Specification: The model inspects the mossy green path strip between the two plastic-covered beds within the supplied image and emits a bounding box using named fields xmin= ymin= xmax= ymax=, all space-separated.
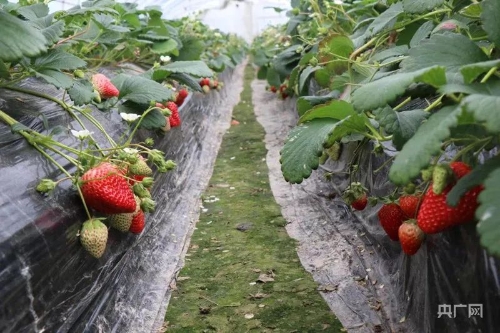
xmin=165 ymin=66 xmax=342 ymax=333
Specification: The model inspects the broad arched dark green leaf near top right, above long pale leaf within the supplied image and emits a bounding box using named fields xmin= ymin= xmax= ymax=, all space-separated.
xmin=401 ymin=33 xmax=488 ymax=81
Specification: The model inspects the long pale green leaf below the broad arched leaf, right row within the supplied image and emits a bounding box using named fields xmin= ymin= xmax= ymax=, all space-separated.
xmin=352 ymin=67 xmax=446 ymax=112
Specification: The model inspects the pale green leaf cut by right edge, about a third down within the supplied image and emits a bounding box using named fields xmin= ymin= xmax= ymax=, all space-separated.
xmin=461 ymin=94 xmax=500 ymax=133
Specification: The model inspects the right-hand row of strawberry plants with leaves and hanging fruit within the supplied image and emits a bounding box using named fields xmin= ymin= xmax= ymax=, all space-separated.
xmin=252 ymin=0 xmax=500 ymax=256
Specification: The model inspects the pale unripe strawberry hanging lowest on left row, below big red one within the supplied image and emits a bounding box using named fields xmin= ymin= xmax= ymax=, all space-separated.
xmin=80 ymin=219 xmax=108 ymax=258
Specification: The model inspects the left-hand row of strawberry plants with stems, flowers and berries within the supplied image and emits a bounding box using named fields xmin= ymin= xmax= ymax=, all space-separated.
xmin=0 ymin=1 xmax=247 ymax=258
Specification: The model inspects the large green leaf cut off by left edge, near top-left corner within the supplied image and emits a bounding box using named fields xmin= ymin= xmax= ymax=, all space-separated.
xmin=0 ymin=10 xmax=48 ymax=61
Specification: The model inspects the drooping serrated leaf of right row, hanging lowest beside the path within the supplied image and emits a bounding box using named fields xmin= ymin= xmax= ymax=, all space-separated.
xmin=280 ymin=118 xmax=338 ymax=184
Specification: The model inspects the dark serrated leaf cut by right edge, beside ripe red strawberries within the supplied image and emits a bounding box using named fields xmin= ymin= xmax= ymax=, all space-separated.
xmin=476 ymin=169 xmax=500 ymax=256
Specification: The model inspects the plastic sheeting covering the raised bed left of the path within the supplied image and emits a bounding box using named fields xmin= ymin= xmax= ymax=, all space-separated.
xmin=0 ymin=63 xmax=238 ymax=333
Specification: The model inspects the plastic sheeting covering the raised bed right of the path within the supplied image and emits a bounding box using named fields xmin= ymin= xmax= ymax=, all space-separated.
xmin=253 ymin=81 xmax=500 ymax=333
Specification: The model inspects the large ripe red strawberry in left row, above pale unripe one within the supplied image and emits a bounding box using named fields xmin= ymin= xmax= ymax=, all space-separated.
xmin=81 ymin=162 xmax=137 ymax=214
